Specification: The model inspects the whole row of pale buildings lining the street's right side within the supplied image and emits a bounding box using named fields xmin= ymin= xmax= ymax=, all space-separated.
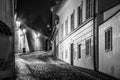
xmin=51 ymin=0 xmax=120 ymax=78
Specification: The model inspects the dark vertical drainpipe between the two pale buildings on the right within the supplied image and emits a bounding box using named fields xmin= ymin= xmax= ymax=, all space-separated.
xmin=93 ymin=0 xmax=99 ymax=71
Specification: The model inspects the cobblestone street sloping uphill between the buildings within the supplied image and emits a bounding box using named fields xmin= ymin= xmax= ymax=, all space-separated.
xmin=16 ymin=53 xmax=95 ymax=80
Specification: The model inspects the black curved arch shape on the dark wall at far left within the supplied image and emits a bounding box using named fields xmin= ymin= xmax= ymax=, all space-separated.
xmin=0 ymin=20 xmax=12 ymax=36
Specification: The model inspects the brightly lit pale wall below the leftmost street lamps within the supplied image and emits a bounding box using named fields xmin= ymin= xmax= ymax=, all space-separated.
xmin=15 ymin=23 xmax=29 ymax=53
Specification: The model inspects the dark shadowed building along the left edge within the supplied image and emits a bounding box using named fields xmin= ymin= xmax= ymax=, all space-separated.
xmin=0 ymin=0 xmax=15 ymax=79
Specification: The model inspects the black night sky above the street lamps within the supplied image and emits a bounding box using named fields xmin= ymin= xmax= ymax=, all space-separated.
xmin=17 ymin=0 xmax=55 ymax=36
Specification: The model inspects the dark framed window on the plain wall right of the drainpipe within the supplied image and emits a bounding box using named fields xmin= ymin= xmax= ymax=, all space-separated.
xmin=105 ymin=28 xmax=112 ymax=52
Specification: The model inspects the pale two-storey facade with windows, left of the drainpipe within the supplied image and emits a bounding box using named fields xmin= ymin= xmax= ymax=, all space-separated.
xmin=56 ymin=0 xmax=94 ymax=69
